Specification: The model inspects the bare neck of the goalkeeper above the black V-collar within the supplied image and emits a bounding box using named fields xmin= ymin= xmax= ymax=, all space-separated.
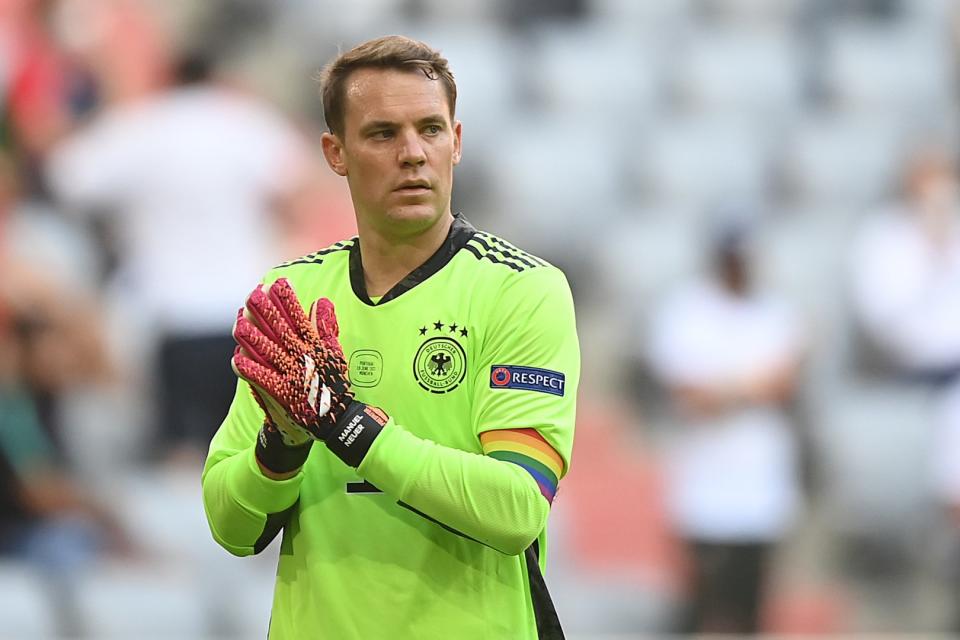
xmin=359 ymin=214 xmax=453 ymax=297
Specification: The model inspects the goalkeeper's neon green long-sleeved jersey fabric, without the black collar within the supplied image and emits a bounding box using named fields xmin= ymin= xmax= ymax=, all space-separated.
xmin=203 ymin=226 xmax=580 ymax=640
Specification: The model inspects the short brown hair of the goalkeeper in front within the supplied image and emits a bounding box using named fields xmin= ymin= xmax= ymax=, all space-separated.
xmin=319 ymin=36 xmax=457 ymax=135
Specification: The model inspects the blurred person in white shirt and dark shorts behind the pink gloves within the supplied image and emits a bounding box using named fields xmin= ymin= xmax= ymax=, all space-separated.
xmin=49 ymin=50 xmax=316 ymax=455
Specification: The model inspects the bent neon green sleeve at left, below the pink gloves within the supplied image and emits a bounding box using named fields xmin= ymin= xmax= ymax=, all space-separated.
xmin=201 ymin=380 xmax=303 ymax=556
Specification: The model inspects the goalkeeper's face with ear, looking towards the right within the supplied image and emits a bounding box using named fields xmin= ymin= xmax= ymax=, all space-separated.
xmin=323 ymin=69 xmax=460 ymax=237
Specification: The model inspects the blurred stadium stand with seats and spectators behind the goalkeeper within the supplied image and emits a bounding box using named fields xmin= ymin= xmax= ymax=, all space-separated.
xmin=0 ymin=0 xmax=960 ymax=638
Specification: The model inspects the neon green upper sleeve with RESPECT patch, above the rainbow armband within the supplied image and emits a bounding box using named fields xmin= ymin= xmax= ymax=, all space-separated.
xmin=473 ymin=267 xmax=580 ymax=475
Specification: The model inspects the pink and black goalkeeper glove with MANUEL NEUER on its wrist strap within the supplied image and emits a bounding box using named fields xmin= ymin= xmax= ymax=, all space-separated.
xmin=231 ymin=278 xmax=386 ymax=468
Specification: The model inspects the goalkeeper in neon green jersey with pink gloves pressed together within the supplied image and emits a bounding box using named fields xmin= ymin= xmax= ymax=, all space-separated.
xmin=203 ymin=36 xmax=580 ymax=640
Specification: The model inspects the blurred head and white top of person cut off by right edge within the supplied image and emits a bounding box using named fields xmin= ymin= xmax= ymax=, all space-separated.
xmin=852 ymin=148 xmax=960 ymax=383
